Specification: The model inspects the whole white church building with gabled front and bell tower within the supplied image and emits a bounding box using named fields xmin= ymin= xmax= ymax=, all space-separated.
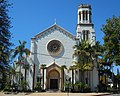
xmin=27 ymin=4 xmax=98 ymax=91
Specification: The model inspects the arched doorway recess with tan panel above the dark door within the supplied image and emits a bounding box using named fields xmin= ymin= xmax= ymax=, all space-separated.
xmin=48 ymin=70 xmax=60 ymax=89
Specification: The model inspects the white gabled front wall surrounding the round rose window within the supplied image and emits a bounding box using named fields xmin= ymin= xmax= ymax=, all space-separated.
xmin=31 ymin=25 xmax=75 ymax=90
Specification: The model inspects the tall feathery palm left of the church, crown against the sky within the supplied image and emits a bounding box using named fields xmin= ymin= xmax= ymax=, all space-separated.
xmin=11 ymin=40 xmax=30 ymax=87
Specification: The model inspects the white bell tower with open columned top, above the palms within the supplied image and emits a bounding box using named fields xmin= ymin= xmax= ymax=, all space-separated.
xmin=76 ymin=4 xmax=96 ymax=44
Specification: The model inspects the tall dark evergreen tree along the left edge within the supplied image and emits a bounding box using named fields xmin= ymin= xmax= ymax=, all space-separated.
xmin=0 ymin=0 xmax=12 ymax=88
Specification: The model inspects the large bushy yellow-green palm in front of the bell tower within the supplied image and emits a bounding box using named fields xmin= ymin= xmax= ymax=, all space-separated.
xmin=73 ymin=40 xmax=91 ymax=82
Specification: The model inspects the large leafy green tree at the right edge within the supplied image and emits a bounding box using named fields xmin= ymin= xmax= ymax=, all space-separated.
xmin=101 ymin=16 xmax=120 ymax=65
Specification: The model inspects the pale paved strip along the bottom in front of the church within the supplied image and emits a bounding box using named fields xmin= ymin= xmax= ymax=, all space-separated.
xmin=0 ymin=92 xmax=113 ymax=96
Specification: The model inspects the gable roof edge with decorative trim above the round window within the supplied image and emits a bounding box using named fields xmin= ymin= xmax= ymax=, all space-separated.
xmin=31 ymin=24 xmax=75 ymax=40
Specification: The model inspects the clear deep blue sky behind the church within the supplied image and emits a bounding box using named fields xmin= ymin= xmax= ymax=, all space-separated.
xmin=9 ymin=0 xmax=120 ymax=73
